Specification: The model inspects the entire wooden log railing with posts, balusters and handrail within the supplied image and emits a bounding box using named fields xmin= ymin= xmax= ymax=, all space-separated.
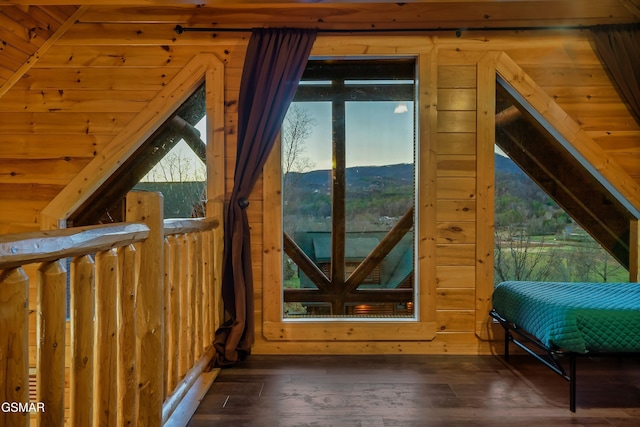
xmin=0 ymin=193 xmax=220 ymax=427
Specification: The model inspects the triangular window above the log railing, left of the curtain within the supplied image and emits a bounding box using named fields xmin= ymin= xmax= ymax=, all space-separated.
xmin=68 ymin=84 xmax=206 ymax=226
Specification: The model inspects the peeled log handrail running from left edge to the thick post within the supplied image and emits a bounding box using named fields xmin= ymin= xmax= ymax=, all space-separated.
xmin=0 ymin=222 xmax=149 ymax=270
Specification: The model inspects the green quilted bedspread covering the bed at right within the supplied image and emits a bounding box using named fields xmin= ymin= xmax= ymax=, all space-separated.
xmin=493 ymin=282 xmax=640 ymax=353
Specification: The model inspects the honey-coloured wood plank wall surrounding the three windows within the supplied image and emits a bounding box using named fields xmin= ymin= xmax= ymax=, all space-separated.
xmin=0 ymin=5 xmax=640 ymax=362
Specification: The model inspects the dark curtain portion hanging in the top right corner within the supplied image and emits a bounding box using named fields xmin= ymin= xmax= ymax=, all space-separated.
xmin=591 ymin=24 xmax=640 ymax=123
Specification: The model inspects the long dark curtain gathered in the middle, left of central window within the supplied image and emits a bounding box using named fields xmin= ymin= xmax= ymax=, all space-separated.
xmin=214 ymin=28 xmax=316 ymax=366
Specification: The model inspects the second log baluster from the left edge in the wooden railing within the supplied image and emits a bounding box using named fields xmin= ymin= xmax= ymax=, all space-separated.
xmin=36 ymin=261 xmax=67 ymax=426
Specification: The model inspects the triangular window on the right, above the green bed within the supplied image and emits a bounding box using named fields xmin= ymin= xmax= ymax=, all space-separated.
xmin=494 ymin=78 xmax=632 ymax=282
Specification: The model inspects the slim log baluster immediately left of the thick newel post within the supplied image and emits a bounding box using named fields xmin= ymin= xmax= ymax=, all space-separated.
xmin=116 ymin=245 xmax=138 ymax=426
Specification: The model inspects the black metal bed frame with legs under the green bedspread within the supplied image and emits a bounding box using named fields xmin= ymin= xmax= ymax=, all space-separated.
xmin=489 ymin=310 xmax=581 ymax=412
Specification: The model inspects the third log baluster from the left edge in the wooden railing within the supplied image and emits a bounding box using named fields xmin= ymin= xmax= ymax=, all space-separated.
xmin=69 ymin=255 xmax=95 ymax=426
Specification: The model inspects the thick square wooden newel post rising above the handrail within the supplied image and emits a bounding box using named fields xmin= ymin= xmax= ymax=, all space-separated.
xmin=126 ymin=192 xmax=164 ymax=426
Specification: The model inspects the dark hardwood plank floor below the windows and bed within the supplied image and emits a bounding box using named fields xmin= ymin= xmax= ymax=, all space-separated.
xmin=188 ymin=355 xmax=640 ymax=427
